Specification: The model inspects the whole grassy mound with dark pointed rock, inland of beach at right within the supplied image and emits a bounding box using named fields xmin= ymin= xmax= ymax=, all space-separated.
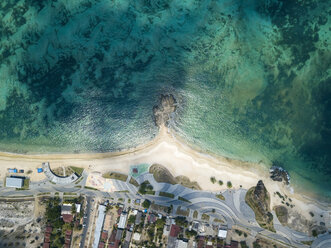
xmin=245 ymin=180 xmax=275 ymax=231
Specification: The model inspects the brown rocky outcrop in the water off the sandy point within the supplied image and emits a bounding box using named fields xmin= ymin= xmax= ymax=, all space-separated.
xmin=153 ymin=95 xmax=176 ymax=127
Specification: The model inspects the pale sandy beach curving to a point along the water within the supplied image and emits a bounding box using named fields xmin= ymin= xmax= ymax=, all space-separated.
xmin=0 ymin=127 xmax=331 ymax=225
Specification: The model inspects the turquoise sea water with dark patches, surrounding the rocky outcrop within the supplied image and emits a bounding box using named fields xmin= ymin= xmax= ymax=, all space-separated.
xmin=0 ymin=0 xmax=331 ymax=197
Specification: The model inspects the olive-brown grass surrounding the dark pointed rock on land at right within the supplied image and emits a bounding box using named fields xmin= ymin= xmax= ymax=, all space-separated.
xmin=245 ymin=187 xmax=275 ymax=232
